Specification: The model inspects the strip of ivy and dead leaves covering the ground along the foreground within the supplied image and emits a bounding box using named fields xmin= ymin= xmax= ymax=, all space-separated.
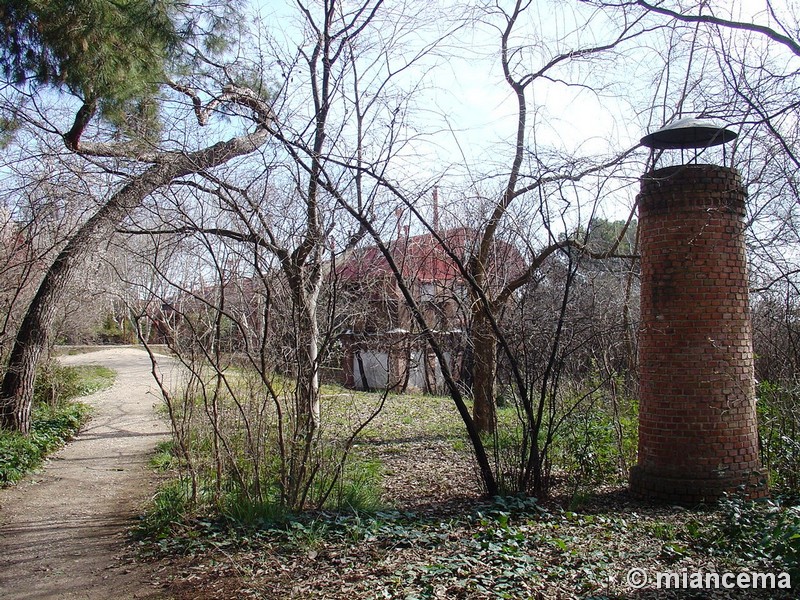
xmin=134 ymin=497 xmax=798 ymax=599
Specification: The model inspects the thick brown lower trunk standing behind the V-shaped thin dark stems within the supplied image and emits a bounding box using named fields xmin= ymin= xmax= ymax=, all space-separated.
xmin=470 ymin=309 xmax=497 ymax=433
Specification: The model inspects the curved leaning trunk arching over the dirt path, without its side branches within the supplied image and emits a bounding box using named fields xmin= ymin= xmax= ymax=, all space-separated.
xmin=0 ymin=130 xmax=268 ymax=433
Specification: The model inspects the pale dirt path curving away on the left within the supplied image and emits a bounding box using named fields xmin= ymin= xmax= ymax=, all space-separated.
xmin=0 ymin=348 xmax=176 ymax=600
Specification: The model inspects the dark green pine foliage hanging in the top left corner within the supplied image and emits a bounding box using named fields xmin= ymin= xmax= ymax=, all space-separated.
xmin=0 ymin=0 xmax=181 ymax=147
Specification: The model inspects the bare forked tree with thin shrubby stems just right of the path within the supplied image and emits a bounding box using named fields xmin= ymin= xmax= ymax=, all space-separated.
xmin=105 ymin=0 xmax=454 ymax=509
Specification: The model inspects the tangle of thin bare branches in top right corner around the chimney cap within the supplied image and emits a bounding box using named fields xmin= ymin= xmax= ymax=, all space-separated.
xmin=583 ymin=0 xmax=800 ymax=289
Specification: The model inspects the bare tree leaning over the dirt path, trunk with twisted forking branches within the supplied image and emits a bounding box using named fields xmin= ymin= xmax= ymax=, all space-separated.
xmin=0 ymin=55 xmax=272 ymax=432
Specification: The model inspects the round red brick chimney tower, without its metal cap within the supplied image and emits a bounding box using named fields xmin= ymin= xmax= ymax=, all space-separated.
xmin=630 ymin=165 xmax=767 ymax=504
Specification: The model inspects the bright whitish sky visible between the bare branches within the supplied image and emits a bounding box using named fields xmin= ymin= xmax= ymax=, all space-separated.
xmin=188 ymin=0 xmax=796 ymax=268
